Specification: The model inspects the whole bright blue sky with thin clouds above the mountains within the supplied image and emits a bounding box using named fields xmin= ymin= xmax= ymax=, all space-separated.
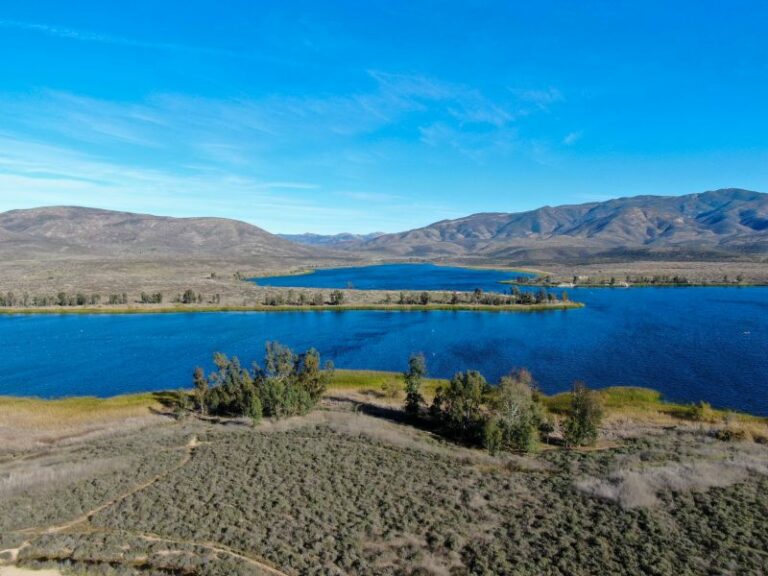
xmin=0 ymin=0 xmax=768 ymax=233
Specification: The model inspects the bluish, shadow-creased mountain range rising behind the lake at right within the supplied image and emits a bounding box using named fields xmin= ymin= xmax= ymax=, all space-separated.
xmin=340 ymin=188 xmax=768 ymax=262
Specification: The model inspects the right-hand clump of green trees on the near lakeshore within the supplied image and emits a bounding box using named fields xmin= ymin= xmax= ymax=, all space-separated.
xmin=403 ymin=354 xmax=603 ymax=454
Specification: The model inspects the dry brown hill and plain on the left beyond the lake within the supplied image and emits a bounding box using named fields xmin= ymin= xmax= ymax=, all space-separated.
xmin=0 ymin=207 xmax=358 ymax=305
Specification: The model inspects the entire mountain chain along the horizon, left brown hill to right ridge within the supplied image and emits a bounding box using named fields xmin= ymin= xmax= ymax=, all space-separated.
xmin=0 ymin=188 xmax=768 ymax=263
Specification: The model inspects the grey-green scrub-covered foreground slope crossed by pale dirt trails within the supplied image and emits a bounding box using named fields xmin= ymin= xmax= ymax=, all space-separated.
xmin=0 ymin=398 xmax=768 ymax=575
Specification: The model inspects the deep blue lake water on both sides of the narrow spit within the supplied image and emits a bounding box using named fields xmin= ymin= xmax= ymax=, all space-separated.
xmin=0 ymin=265 xmax=768 ymax=415
